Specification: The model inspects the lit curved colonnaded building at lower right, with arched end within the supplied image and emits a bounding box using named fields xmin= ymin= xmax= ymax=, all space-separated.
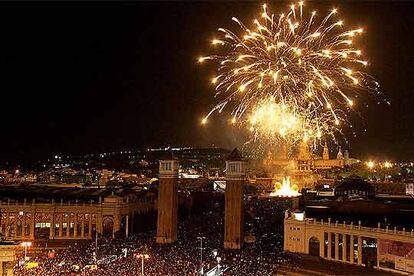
xmin=284 ymin=212 xmax=414 ymax=273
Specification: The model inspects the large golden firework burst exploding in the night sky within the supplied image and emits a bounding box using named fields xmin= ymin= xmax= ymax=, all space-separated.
xmin=198 ymin=2 xmax=372 ymax=147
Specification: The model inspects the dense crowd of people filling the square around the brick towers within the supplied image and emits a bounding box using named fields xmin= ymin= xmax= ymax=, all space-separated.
xmin=15 ymin=194 xmax=291 ymax=276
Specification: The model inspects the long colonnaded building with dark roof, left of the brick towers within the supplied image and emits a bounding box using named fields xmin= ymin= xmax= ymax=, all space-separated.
xmin=0 ymin=185 xmax=156 ymax=240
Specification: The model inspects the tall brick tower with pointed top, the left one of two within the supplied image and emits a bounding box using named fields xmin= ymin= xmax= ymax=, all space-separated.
xmin=157 ymin=151 xmax=178 ymax=244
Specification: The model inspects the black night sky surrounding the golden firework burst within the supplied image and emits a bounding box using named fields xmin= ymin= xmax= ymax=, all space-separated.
xmin=0 ymin=1 xmax=414 ymax=162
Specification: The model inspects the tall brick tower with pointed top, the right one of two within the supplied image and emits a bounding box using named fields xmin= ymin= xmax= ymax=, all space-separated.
xmin=224 ymin=148 xmax=246 ymax=249
